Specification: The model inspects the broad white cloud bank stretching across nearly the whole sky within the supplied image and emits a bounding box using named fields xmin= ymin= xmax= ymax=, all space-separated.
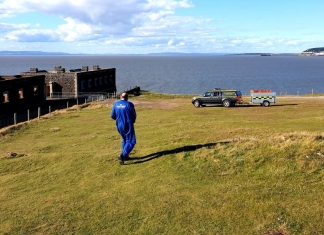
xmin=0 ymin=0 xmax=318 ymax=53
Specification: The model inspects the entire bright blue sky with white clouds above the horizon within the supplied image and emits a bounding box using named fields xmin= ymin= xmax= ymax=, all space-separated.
xmin=0 ymin=0 xmax=324 ymax=54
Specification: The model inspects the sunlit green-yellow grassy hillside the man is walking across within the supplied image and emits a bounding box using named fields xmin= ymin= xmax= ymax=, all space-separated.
xmin=0 ymin=94 xmax=324 ymax=235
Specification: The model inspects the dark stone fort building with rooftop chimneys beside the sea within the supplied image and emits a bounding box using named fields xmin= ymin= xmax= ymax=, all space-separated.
xmin=0 ymin=65 xmax=117 ymax=116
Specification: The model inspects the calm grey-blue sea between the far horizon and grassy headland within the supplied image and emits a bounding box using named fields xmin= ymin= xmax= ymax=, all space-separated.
xmin=0 ymin=55 xmax=324 ymax=95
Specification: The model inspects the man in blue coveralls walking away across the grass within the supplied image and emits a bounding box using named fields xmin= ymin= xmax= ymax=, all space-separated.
xmin=110 ymin=93 xmax=136 ymax=165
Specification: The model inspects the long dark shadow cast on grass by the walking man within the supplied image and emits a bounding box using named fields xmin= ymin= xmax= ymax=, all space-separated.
xmin=126 ymin=141 xmax=230 ymax=165
